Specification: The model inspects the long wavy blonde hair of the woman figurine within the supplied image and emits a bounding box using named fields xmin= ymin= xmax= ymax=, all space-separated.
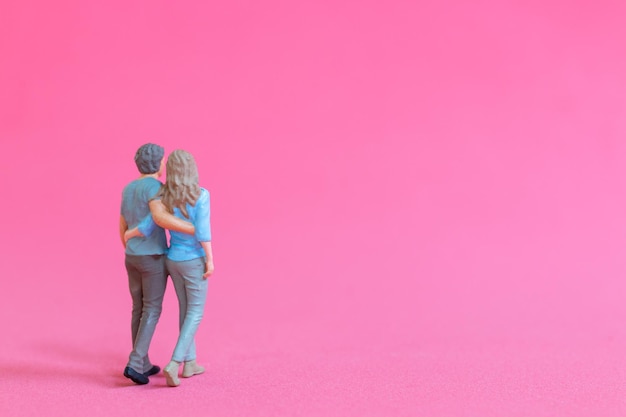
xmin=159 ymin=149 xmax=200 ymax=218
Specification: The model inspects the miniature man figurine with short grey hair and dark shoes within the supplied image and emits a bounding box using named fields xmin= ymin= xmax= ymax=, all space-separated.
xmin=120 ymin=143 xmax=194 ymax=384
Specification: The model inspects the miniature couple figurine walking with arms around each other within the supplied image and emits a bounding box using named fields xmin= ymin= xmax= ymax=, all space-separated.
xmin=120 ymin=143 xmax=214 ymax=387
